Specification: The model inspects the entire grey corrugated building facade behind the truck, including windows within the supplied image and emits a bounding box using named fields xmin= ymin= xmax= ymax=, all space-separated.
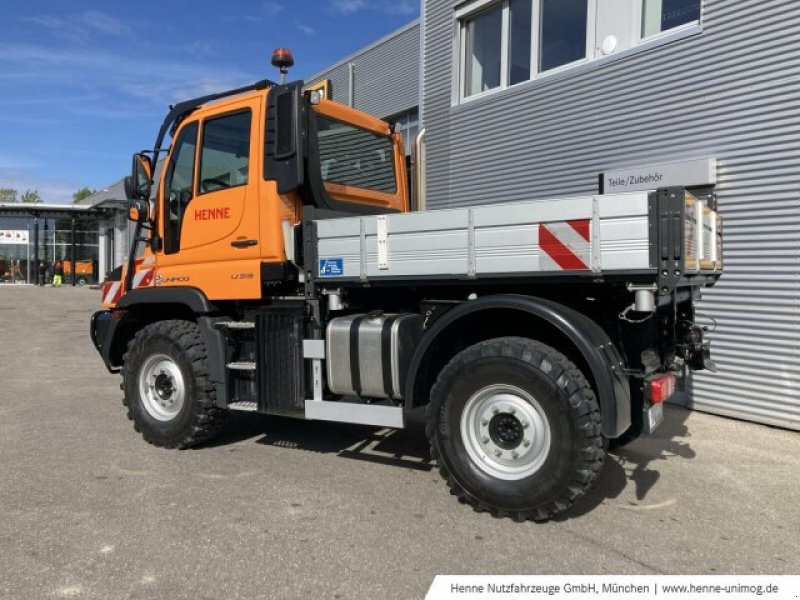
xmin=308 ymin=0 xmax=800 ymax=429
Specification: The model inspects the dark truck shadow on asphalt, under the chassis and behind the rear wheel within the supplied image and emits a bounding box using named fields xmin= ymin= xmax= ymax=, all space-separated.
xmin=202 ymin=405 xmax=695 ymax=521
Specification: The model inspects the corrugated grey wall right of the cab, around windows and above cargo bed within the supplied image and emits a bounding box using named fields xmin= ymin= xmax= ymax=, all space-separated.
xmin=424 ymin=0 xmax=800 ymax=429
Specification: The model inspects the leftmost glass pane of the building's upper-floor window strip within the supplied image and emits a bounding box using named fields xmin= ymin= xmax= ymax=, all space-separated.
xmin=464 ymin=5 xmax=503 ymax=96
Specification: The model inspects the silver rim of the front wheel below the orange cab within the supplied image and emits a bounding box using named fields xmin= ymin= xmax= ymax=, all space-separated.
xmin=139 ymin=354 xmax=186 ymax=421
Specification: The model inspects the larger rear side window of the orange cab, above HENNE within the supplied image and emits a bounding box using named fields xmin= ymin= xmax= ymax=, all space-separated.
xmin=198 ymin=110 xmax=251 ymax=194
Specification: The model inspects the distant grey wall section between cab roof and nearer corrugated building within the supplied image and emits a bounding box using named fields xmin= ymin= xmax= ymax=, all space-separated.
xmin=309 ymin=21 xmax=420 ymax=118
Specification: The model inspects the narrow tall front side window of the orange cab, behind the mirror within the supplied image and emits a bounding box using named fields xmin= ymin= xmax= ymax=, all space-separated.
xmin=164 ymin=123 xmax=197 ymax=254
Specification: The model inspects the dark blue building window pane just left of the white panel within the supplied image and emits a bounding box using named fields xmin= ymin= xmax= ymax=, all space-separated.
xmin=539 ymin=0 xmax=589 ymax=72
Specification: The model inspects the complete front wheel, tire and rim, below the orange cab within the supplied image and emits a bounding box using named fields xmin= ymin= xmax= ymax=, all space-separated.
xmin=123 ymin=320 xmax=227 ymax=448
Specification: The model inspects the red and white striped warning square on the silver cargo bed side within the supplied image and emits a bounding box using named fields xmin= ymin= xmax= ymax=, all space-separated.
xmin=539 ymin=219 xmax=592 ymax=271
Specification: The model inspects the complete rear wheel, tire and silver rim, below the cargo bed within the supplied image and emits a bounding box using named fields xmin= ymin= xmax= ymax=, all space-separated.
xmin=427 ymin=338 xmax=605 ymax=521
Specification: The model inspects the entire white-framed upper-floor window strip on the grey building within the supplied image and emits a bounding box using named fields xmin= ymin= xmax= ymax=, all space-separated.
xmin=455 ymin=0 xmax=702 ymax=100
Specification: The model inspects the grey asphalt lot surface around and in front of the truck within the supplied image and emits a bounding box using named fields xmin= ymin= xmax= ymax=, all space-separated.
xmin=0 ymin=286 xmax=800 ymax=600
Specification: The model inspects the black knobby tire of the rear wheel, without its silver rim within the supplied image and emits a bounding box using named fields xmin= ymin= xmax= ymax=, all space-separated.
xmin=426 ymin=337 xmax=606 ymax=521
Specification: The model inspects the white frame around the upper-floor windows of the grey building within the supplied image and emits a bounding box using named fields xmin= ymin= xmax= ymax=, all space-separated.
xmin=452 ymin=0 xmax=705 ymax=106
